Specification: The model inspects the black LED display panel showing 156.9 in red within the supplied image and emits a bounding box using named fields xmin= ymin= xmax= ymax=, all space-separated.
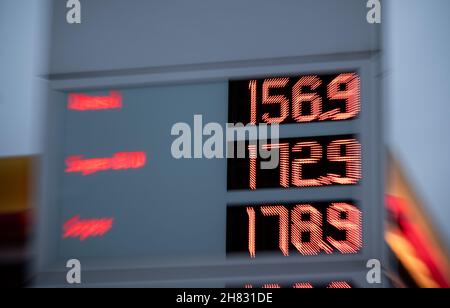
xmin=229 ymin=72 xmax=361 ymax=124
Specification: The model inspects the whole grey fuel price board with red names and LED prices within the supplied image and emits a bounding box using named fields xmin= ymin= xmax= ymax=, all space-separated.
xmin=37 ymin=61 xmax=382 ymax=288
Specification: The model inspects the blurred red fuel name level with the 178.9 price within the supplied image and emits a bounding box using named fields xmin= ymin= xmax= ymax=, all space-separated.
xmin=63 ymin=215 xmax=114 ymax=241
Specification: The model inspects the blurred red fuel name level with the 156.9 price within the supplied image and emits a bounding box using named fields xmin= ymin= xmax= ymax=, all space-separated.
xmin=68 ymin=91 xmax=122 ymax=111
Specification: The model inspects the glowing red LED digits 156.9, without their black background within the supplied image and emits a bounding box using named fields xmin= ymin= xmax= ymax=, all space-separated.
xmin=248 ymin=73 xmax=361 ymax=124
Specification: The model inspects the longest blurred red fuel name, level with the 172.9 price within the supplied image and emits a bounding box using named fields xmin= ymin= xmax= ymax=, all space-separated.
xmin=66 ymin=152 xmax=147 ymax=176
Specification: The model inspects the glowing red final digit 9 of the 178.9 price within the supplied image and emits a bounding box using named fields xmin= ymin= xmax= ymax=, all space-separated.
xmin=327 ymin=203 xmax=362 ymax=254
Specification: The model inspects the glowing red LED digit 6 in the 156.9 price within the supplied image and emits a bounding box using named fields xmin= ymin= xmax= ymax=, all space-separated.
xmin=292 ymin=76 xmax=322 ymax=123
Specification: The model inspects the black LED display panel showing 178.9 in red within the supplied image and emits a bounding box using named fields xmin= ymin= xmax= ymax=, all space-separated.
xmin=227 ymin=201 xmax=363 ymax=258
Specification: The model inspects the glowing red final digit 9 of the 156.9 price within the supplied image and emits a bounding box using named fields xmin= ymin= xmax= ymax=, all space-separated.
xmin=321 ymin=73 xmax=361 ymax=121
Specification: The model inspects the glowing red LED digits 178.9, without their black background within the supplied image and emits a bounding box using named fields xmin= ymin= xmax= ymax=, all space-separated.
xmin=246 ymin=202 xmax=362 ymax=258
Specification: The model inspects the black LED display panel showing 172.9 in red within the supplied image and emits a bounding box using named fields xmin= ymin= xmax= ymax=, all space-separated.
xmin=228 ymin=135 xmax=362 ymax=190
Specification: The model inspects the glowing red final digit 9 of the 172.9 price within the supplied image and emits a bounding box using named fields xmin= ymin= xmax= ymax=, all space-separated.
xmin=327 ymin=139 xmax=361 ymax=185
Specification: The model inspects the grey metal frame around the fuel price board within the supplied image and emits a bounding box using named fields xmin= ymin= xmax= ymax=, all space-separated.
xmin=34 ymin=52 xmax=384 ymax=286
